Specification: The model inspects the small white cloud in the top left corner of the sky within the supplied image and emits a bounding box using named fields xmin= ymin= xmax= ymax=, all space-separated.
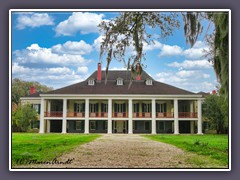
xmin=16 ymin=13 xmax=54 ymax=29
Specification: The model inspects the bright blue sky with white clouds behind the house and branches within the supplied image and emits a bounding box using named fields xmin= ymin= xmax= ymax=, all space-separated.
xmin=11 ymin=11 xmax=217 ymax=92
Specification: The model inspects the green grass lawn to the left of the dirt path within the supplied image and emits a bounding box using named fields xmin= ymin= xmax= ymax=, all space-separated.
xmin=12 ymin=133 xmax=100 ymax=166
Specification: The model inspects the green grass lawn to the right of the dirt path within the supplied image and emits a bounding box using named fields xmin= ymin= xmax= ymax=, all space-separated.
xmin=144 ymin=134 xmax=228 ymax=167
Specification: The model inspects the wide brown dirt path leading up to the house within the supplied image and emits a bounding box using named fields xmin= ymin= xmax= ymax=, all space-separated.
xmin=16 ymin=134 xmax=201 ymax=168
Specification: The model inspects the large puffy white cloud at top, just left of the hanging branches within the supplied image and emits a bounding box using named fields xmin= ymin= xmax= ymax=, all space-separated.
xmin=55 ymin=12 xmax=104 ymax=36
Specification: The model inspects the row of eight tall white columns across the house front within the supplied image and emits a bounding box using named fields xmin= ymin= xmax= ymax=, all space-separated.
xmin=39 ymin=98 xmax=202 ymax=134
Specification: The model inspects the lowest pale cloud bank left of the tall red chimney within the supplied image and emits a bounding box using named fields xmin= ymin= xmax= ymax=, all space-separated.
xmin=12 ymin=63 xmax=88 ymax=89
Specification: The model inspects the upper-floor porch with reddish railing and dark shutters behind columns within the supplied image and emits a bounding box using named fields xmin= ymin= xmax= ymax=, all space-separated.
xmin=44 ymin=99 xmax=198 ymax=119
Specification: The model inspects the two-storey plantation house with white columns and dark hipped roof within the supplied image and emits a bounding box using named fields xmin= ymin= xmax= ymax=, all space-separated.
xmin=21 ymin=63 xmax=203 ymax=134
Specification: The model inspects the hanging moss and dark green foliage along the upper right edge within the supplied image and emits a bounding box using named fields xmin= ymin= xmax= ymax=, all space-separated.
xmin=183 ymin=12 xmax=229 ymax=101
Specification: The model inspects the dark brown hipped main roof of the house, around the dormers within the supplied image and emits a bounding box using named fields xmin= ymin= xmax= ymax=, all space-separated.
xmin=44 ymin=71 xmax=195 ymax=95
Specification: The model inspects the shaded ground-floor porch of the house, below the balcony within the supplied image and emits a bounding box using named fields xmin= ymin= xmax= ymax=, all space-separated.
xmin=44 ymin=119 xmax=201 ymax=134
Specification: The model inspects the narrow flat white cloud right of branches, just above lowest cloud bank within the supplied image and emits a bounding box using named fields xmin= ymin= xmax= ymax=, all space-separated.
xmin=167 ymin=60 xmax=212 ymax=69
